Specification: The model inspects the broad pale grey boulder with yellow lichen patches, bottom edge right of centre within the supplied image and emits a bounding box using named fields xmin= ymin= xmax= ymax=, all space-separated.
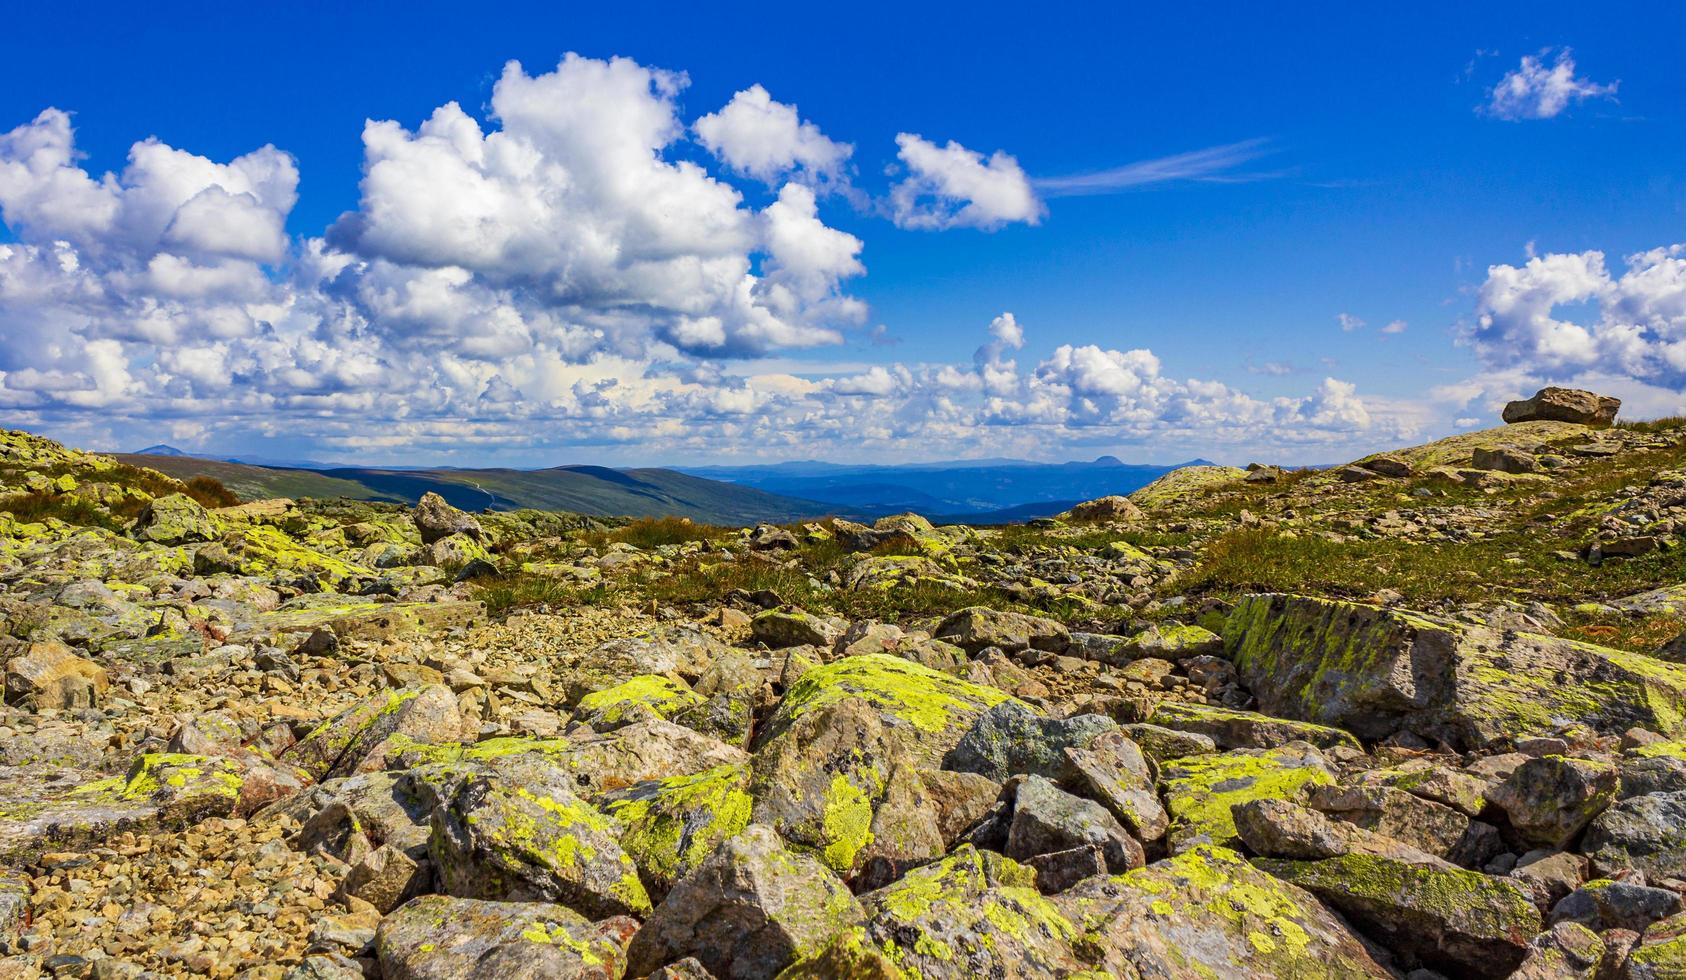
xmin=1054 ymin=845 xmax=1393 ymax=980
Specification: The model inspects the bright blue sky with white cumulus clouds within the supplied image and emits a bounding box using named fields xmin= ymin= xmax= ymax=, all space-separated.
xmin=0 ymin=3 xmax=1686 ymax=464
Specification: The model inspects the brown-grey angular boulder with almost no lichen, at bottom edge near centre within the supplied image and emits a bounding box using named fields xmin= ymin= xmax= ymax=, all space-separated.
xmin=627 ymin=825 xmax=865 ymax=980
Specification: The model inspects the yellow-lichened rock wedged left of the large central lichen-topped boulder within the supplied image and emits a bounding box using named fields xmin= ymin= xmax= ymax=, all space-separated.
xmin=602 ymin=766 xmax=754 ymax=902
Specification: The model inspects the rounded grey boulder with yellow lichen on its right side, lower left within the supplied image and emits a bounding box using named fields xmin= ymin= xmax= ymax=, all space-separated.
xmin=428 ymin=759 xmax=651 ymax=918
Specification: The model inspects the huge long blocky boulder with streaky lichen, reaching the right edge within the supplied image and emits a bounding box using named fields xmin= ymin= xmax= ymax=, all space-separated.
xmin=1224 ymin=594 xmax=1686 ymax=751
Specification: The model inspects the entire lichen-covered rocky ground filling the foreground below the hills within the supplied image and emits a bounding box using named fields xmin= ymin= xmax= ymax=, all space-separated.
xmin=0 ymin=384 xmax=1686 ymax=980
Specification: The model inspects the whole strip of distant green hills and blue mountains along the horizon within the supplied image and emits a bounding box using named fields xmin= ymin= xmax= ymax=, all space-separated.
xmin=120 ymin=444 xmax=1204 ymax=525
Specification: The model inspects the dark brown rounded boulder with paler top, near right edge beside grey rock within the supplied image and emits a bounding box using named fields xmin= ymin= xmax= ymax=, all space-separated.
xmin=1487 ymin=756 xmax=1620 ymax=850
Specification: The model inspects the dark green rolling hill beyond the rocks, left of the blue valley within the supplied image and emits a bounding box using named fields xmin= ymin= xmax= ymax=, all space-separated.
xmin=118 ymin=454 xmax=838 ymax=525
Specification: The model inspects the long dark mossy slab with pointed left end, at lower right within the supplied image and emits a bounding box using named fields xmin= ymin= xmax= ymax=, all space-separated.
xmin=1256 ymin=853 xmax=1541 ymax=977
